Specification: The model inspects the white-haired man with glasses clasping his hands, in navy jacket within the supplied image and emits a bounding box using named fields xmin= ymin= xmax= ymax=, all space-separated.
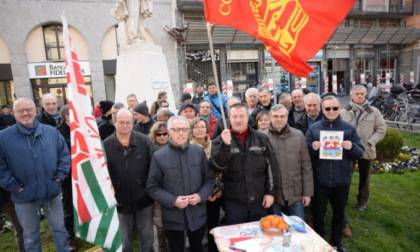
xmin=147 ymin=116 xmax=214 ymax=252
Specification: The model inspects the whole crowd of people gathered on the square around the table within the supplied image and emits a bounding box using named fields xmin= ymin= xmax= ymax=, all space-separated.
xmin=0 ymin=83 xmax=386 ymax=252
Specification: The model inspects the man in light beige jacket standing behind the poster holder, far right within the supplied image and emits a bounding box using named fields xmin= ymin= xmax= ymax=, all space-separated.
xmin=340 ymin=85 xmax=386 ymax=236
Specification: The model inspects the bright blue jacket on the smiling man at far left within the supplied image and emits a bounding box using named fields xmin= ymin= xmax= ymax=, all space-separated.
xmin=0 ymin=120 xmax=70 ymax=203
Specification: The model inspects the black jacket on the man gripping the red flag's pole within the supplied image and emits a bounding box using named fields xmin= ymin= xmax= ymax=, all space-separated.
xmin=210 ymin=127 xmax=278 ymax=203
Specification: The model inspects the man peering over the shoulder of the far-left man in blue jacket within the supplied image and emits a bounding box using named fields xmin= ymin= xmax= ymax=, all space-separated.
xmin=35 ymin=93 xmax=61 ymax=127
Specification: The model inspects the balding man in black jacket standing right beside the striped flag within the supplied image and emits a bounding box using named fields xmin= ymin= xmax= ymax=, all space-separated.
xmin=104 ymin=108 xmax=153 ymax=251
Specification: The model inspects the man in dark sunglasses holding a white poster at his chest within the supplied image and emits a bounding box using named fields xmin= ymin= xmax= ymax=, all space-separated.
xmin=306 ymin=96 xmax=365 ymax=251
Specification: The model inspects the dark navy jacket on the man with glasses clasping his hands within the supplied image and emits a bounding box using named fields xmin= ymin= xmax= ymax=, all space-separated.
xmin=146 ymin=142 xmax=214 ymax=231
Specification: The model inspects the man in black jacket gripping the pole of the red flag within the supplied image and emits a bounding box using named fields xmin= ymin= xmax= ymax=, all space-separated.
xmin=210 ymin=103 xmax=278 ymax=224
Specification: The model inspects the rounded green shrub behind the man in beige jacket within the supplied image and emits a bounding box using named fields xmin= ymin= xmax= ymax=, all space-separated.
xmin=376 ymin=129 xmax=404 ymax=160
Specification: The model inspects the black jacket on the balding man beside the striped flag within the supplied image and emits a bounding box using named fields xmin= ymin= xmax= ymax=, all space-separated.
xmin=104 ymin=131 xmax=153 ymax=213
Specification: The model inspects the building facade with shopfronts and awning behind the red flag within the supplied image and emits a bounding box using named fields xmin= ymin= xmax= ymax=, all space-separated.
xmin=177 ymin=0 xmax=420 ymax=97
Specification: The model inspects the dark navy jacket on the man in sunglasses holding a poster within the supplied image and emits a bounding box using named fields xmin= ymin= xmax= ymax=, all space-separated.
xmin=306 ymin=117 xmax=365 ymax=188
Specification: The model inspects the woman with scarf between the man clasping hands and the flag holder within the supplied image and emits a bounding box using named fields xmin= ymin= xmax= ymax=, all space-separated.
xmin=190 ymin=117 xmax=222 ymax=252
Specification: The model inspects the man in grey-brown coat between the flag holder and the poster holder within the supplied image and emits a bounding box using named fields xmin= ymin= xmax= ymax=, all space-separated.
xmin=264 ymin=105 xmax=314 ymax=220
